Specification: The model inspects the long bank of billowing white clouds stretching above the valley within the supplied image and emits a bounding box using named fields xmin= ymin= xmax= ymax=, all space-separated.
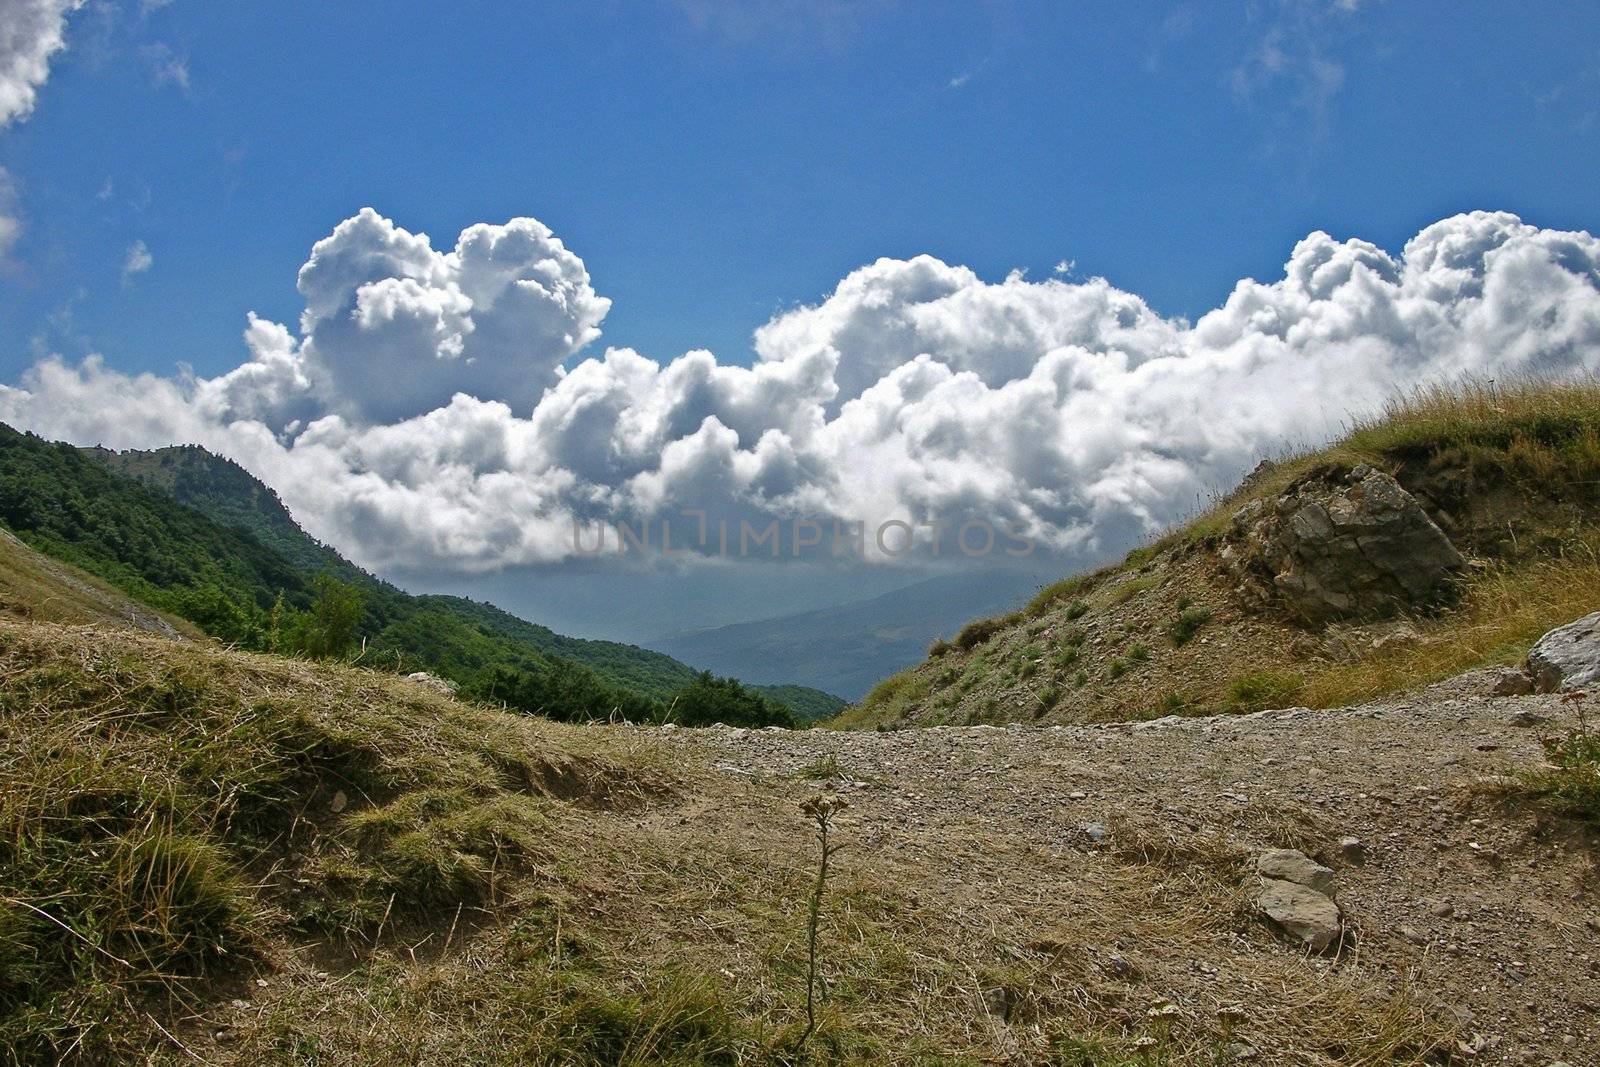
xmin=0 ymin=211 xmax=1600 ymax=569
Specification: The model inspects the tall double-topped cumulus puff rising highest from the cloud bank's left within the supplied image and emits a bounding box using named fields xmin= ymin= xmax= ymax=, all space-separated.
xmin=240 ymin=208 xmax=611 ymax=422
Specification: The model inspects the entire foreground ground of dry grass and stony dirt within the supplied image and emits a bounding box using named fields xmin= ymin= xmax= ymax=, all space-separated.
xmin=0 ymin=617 xmax=1594 ymax=1067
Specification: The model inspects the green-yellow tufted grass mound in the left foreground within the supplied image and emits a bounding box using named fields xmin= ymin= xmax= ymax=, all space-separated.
xmin=0 ymin=622 xmax=760 ymax=1064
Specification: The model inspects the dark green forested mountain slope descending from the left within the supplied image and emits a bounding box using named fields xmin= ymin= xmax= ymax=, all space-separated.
xmin=0 ymin=426 xmax=843 ymax=723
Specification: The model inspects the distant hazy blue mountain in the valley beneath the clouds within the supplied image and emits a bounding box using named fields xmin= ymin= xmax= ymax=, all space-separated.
xmin=643 ymin=569 xmax=1045 ymax=701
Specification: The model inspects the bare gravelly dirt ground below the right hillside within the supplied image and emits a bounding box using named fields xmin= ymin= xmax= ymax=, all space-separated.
xmin=630 ymin=673 xmax=1600 ymax=1065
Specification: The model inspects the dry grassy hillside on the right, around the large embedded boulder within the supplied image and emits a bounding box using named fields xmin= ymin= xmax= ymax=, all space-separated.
xmin=838 ymin=381 xmax=1600 ymax=726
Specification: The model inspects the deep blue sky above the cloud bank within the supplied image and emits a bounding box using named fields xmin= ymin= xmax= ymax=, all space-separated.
xmin=0 ymin=0 xmax=1600 ymax=382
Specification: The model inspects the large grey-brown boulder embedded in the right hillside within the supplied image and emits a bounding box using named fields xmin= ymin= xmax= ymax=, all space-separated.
xmin=1222 ymin=464 xmax=1466 ymax=624
